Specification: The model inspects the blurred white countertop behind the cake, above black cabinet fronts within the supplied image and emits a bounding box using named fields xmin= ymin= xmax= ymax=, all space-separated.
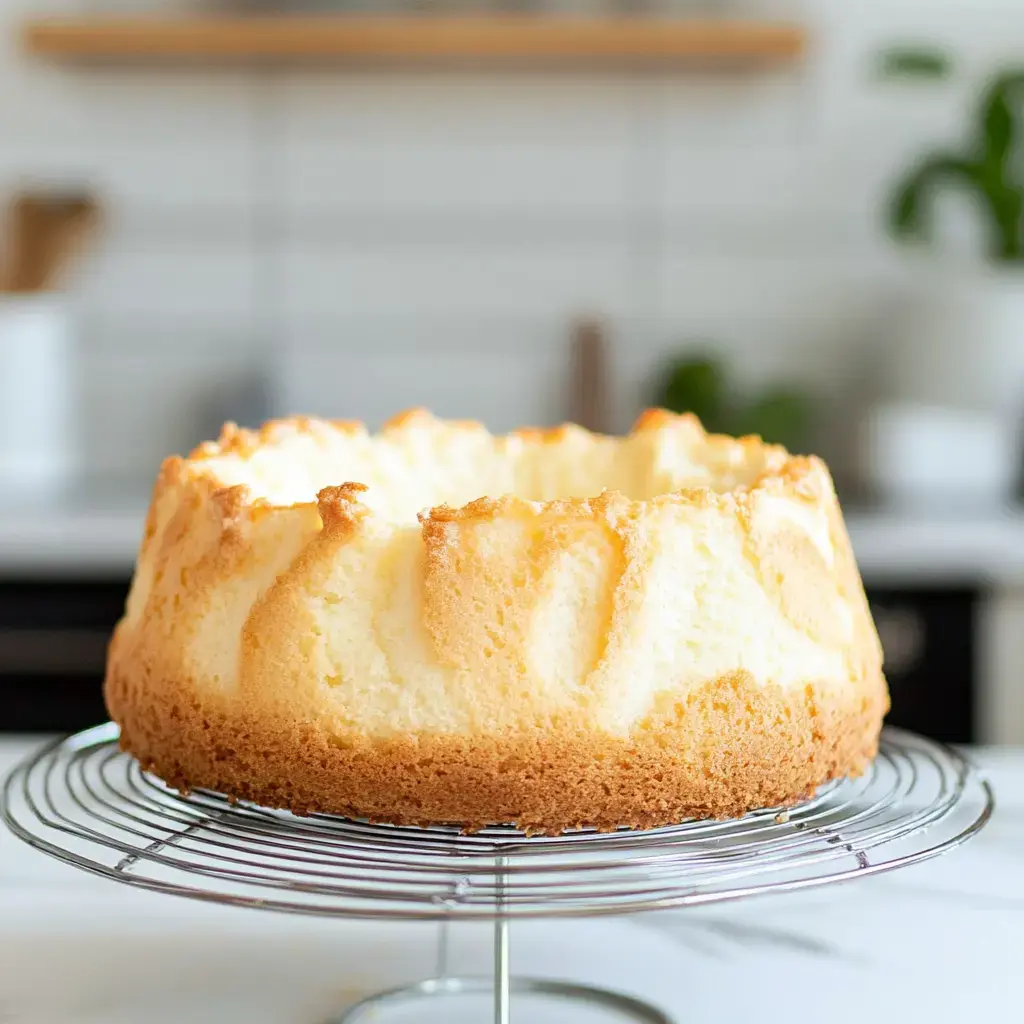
xmin=6 ymin=489 xmax=1024 ymax=586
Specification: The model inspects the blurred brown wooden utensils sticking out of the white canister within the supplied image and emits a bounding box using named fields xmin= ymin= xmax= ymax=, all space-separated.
xmin=4 ymin=194 xmax=99 ymax=293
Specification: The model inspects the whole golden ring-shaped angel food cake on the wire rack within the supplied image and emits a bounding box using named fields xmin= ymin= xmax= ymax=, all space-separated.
xmin=105 ymin=411 xmax=889 ymax=833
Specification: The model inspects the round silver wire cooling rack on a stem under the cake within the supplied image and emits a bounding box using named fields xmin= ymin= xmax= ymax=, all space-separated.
xmin=3 ymin=724 xmax=993 ymax=1024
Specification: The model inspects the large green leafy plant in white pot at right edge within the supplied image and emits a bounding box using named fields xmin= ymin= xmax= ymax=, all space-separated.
xmin=886 ymin=69 xmax=1024 ymax=422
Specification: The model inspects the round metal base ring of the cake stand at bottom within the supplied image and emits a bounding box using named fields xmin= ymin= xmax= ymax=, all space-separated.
xmin=326 ymin=978 xmax=677 ymax=1024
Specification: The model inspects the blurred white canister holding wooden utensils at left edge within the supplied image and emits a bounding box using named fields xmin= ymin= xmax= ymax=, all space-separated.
xmin=0 ymin=294 xmax=75 ymax=501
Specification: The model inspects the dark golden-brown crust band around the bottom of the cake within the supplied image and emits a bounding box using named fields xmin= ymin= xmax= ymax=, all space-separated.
xmin=105 ymin=651 xmax=888 ymax=833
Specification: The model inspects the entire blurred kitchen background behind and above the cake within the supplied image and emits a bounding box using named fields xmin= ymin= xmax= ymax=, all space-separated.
xmin=0 ymin=0 xmax=1024 ymax=743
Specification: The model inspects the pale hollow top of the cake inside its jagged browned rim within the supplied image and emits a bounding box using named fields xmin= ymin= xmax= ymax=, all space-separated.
xmin=185 ymin=410 xmax=792 ymax=522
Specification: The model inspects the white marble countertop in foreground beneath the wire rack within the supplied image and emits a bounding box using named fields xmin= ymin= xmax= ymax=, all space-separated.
xmin=0 ymin=740 xmax=1024 ymax=1024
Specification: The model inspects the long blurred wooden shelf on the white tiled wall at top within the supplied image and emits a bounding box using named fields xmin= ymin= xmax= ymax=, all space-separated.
xmin=24 ymin=14 xmax=805 ymax=66
